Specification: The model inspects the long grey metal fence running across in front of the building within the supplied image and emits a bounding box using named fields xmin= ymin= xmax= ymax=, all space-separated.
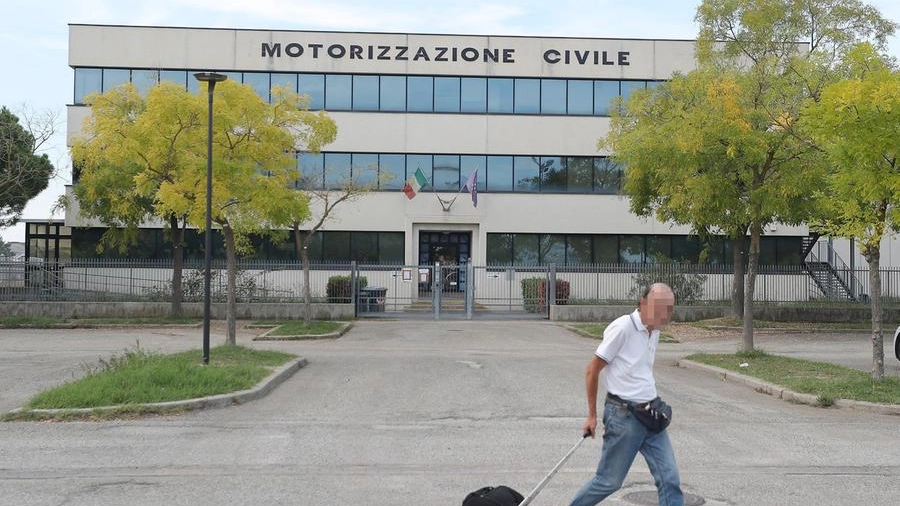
xmin=0 ymin=259 xmax=900 ymax=311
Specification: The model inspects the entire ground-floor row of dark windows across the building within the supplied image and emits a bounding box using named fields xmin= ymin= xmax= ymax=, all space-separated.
xmin=72 ymin=228 xmax=802 ymax=266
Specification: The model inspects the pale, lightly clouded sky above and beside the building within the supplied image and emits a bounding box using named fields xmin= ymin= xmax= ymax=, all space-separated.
xmin=0 ymin=0 xmax=900 ymax=242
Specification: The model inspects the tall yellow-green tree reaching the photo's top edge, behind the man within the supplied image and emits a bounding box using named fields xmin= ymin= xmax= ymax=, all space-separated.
xmin=605 ymin=0 xmax=895 ymax=350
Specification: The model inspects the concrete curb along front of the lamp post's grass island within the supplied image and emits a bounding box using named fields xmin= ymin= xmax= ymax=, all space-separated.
xmin=10 ymin=357 xmax=308 ymax=416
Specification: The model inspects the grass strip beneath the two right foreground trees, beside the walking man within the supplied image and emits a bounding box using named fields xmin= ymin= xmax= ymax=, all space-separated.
xmin=685 ymin=350 xmax=900 ymax=406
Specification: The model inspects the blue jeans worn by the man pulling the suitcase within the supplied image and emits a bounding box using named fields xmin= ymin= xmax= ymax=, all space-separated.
xmin=571 ymin=402 xmax=684 ymax=506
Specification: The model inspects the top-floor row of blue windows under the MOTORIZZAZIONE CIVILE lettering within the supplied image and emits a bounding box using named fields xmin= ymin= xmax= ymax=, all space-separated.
xmin=75 ymin=67 xmax=659 ymax=116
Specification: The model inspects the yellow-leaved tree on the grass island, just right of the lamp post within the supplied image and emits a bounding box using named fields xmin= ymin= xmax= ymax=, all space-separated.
xmin=156 ymin=81 xmax=337 ymax=344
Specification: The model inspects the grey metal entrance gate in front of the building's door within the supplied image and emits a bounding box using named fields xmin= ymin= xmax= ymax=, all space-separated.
xmin=351 ymin=263 xmax=555 ymax=320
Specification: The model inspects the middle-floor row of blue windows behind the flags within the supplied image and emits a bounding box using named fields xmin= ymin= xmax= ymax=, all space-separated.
xmin=297 ymin=153 xmax=622 ymax=194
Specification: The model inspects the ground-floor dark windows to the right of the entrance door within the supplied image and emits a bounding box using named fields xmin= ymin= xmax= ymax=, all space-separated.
xmin=487 ymin=234 xmax=802 ymax=265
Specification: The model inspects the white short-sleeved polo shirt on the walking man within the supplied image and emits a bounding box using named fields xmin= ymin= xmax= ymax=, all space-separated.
xmin=594 ymin=310 xmax=659 ymax=402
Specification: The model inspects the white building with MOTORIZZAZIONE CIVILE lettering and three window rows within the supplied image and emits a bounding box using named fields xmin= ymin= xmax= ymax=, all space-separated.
xmin=54 ymin=25 xmax=808 ymax=272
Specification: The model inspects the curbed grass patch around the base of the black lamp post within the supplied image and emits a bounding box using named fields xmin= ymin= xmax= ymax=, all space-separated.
xmin=19 ymin=346 xmax=294 ymax=409
